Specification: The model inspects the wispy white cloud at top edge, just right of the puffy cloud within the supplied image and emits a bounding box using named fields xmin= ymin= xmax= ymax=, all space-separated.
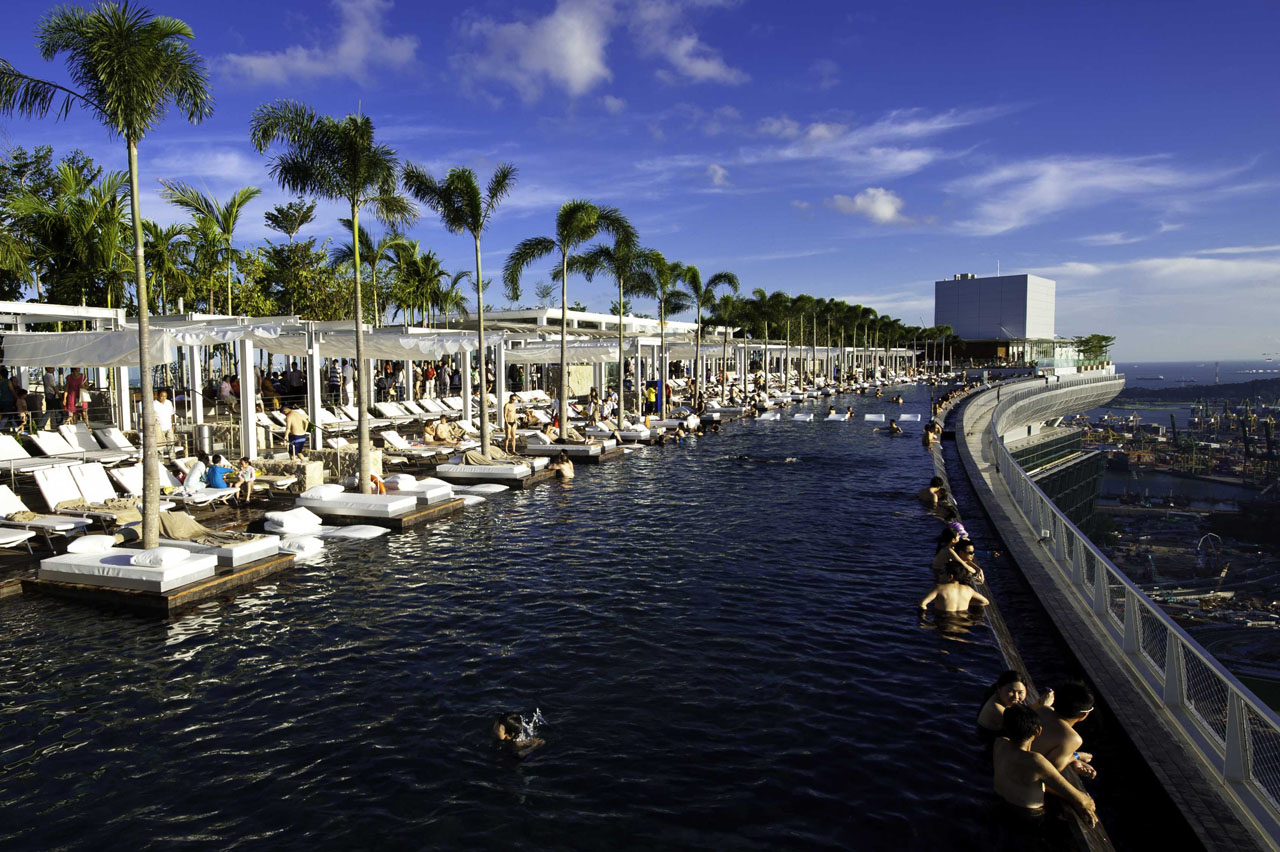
xmin=628 ymin=0 xmax=750 ymax=86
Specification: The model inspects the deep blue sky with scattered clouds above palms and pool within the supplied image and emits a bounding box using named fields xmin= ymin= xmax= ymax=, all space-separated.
xmin=0 ymin=0 xmax=1280 ymax=359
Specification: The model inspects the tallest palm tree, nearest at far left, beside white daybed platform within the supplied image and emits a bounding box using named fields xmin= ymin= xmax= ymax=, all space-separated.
xmin=0 ymin=3 xmax=212 ymax=548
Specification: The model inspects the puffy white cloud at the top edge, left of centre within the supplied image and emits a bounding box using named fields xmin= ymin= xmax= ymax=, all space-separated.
xmin=454 ymin=0 xmax=613 ymax=101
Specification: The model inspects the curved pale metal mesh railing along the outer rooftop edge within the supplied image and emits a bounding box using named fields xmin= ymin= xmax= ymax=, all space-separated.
xmin=987 ymin=375 xmax=1280 ymax=846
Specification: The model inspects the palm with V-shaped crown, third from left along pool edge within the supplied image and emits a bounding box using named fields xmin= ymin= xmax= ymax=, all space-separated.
xmin=404 ymin=162 xmax=518 ymax=455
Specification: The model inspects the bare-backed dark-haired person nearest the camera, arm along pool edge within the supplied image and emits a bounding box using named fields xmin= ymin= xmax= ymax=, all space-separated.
xmin=991 ymin=704 xmax=1098 ymax=828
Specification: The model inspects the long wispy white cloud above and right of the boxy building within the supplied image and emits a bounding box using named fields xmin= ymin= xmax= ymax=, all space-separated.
xmin=948 ymin=156 xmax=1225 ymax=235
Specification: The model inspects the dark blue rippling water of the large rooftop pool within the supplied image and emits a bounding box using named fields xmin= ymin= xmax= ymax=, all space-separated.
xmin=0 ymin=389 xmax=1187 ymax=851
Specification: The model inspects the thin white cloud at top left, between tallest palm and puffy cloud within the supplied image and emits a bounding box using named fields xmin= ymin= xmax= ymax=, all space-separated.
xmin=218 ymin=0 xmax=419 ymax=84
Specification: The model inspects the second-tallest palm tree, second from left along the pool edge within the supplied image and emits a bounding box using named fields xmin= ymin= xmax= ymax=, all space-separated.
xmin=250 ymin=101 xmax=415 ymax=494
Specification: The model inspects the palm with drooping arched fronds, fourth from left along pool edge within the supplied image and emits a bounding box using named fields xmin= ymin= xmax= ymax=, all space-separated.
xmin=502 ymin=198 xmax=636 ymax=440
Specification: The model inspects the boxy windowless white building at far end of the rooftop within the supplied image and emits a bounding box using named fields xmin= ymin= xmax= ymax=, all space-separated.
xmin=933 ymin=274 xmax=1057 ymax=340
